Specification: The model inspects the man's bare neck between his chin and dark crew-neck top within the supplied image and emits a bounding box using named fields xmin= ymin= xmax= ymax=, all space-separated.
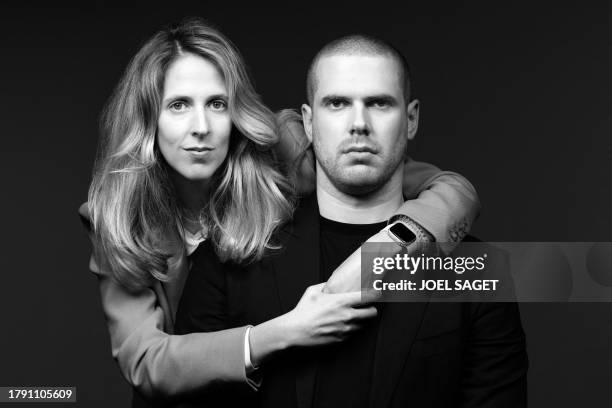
xmin=317 ymin=165 xmax=404 ymax=224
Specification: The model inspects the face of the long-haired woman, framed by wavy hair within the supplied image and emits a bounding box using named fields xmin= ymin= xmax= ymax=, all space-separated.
xmin=157 ymin=54 xmax=232 ymax=184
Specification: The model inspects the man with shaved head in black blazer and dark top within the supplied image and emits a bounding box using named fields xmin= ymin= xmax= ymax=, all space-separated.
xmin=177 ymin=35 xmax=527 ymax=408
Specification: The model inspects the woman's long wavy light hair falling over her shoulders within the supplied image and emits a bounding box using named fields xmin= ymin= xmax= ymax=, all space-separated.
xmin=88 ymin=18 xmax=294 ymax=290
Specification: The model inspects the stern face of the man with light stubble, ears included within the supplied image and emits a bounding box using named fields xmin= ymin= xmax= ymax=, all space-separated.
xmin=302 ymin=55 xmax=418 ymax=195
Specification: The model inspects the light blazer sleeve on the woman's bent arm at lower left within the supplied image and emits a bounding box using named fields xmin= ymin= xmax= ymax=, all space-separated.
xmin=79 ymin=202 xmax=247 ymax=399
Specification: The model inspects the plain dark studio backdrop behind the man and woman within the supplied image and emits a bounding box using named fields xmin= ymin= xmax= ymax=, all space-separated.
xmin=0 ymin=1 xmax=612 ymax=407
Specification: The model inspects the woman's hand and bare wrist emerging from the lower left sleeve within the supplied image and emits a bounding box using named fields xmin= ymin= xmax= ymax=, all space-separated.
xmin=249 ymin=283 xmax=377 ymax=365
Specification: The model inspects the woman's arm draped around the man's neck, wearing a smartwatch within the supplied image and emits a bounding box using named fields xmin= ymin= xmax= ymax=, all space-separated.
xmin=275 ymin=109 xmax=480 ymax=293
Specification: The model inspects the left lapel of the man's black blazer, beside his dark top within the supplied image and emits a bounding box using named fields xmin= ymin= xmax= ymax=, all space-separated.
xmin=272 ymin=194 xmax=320 ymax=408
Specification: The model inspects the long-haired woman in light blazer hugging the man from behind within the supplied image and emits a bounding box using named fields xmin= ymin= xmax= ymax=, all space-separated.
xmin=81 ymin=19 xmax=478 ymax=399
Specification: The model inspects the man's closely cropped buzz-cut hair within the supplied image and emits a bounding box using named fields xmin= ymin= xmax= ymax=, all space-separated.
xmin=306 ymin=34 xmax=412 ymax=105
